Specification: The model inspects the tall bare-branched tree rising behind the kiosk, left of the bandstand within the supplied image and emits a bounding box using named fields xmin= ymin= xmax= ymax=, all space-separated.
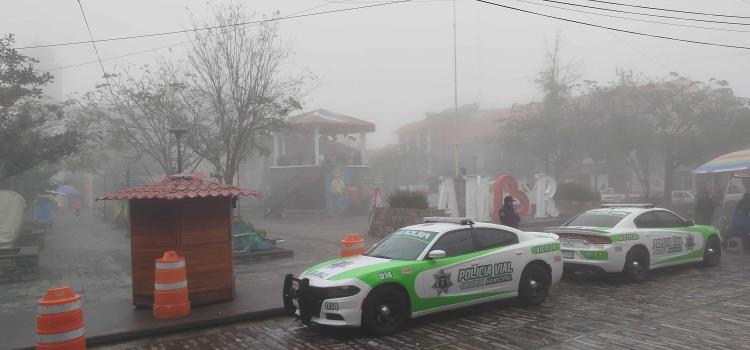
xmin=187 ymin=6 xmax=306 ymax=184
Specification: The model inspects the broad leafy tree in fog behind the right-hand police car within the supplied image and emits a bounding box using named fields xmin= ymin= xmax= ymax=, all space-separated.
xmin=587 ymin=72 xmax=750 ymax=202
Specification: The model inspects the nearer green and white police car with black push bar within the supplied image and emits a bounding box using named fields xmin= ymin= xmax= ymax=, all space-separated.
xmin=283 ymin=218 xmax=562 ymax=335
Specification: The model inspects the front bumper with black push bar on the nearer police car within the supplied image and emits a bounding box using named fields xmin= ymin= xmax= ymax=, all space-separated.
xmin=283 ymin=274 xmax=366 ymax=327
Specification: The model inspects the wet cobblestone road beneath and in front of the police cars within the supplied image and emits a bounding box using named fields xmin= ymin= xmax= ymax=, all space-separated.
xmin=103 ymin=255 xmax=750 ymax=350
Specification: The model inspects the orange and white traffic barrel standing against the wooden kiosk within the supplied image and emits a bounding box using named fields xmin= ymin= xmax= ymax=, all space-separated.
xmin=154 ymin=250 xmax=190 ymax=320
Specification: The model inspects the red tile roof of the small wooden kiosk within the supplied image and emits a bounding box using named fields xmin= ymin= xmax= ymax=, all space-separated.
xmin=96 ymin=174 xmax=256 ymax=200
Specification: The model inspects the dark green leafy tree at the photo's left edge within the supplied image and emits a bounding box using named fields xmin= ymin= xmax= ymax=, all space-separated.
xmin=0 ymin=35 xmax=80 ymax=182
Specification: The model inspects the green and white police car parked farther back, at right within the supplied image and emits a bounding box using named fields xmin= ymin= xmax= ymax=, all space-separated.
xmin=546 ymin=204 xmax=721 ymax=282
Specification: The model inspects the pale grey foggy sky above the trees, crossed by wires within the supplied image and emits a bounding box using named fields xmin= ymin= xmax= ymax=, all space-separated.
xmin=5 ymin=0 xmax=750 ymax=148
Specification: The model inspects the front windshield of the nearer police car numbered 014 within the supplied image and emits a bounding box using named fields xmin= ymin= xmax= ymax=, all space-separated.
xmin=364 ymin=230 xmax=437 ymax=260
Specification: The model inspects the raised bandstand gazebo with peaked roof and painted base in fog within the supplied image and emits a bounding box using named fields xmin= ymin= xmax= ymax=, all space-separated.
xmin=267 ymin=109 xmax=375 ymax=219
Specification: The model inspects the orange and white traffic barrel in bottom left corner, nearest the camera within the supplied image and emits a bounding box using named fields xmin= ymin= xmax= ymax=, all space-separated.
xmin=36 ymin=287 xmax=86 ymax=350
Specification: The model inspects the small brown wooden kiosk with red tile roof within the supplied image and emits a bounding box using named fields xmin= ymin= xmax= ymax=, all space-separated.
xmin=97 ymin=174 xmax=256 ymax=306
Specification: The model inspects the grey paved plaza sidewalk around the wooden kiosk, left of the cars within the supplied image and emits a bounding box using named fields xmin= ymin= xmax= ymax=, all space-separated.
xmin=0 ymin=213 xmax=374 ymax=349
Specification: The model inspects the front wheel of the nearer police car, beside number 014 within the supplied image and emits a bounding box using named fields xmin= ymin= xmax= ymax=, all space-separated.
xmin=362 ymin=286 xmax=409 ymax=336
